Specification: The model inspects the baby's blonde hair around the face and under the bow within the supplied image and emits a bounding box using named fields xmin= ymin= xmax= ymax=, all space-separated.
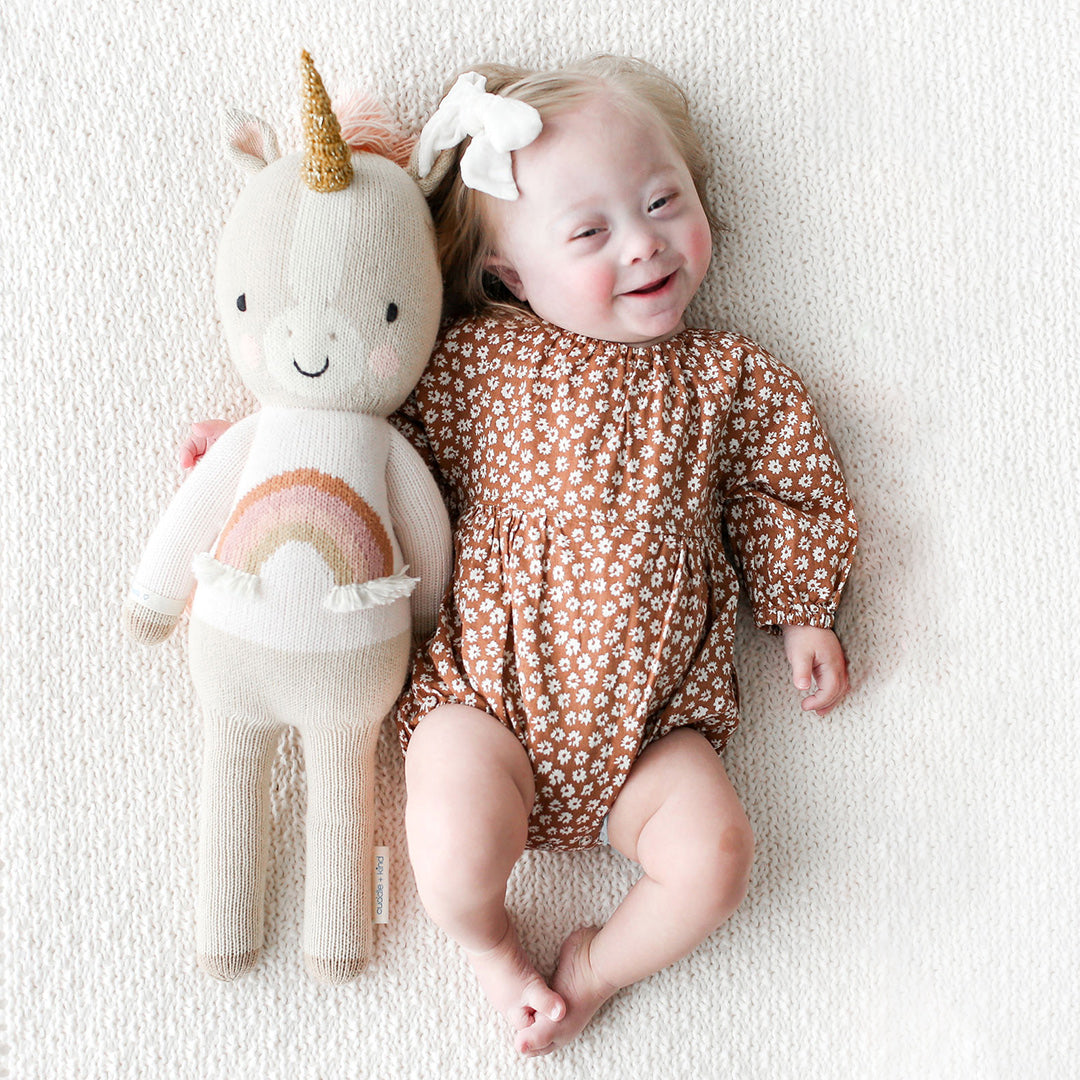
xmin=430 ymin=55 xmax=715 ymax=315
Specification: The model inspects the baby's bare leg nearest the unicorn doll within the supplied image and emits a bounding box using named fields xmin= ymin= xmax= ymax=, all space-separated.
xmin=405 ymin=705 xmax=566 ymax=1029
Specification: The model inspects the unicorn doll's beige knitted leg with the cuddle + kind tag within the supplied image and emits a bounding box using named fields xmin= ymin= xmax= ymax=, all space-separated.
xmin=303 ymin=723 xmax=379 ymax=983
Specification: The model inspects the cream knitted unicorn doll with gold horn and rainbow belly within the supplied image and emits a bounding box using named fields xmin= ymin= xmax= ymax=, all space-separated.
xmin=124 ymin=53 xmax=450 ymax=983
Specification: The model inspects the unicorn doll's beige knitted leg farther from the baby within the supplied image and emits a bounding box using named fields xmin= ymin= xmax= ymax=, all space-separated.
xmin=197 ymin=711 xmax=278 ymax=980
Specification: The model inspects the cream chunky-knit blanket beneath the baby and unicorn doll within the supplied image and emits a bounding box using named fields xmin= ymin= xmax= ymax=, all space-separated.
xmin=0 ymin=0 xmax=1080 ymax=1080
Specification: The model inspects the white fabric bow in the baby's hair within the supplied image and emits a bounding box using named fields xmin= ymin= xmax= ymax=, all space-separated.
xmin=417 ymin=71 xmax=542 ymax=202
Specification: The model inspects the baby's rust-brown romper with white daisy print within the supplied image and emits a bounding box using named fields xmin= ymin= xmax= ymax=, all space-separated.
xmin=395 ymin=313 xmax=856 ymax=849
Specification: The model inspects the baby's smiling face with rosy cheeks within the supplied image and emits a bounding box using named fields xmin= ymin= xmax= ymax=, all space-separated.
xmin=486 ymin=96 xmax=712 ymax=343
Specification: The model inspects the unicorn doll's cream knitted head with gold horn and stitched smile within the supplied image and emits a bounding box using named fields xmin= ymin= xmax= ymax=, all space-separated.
xmin=215 ymin=53 xmax=442 ymax=416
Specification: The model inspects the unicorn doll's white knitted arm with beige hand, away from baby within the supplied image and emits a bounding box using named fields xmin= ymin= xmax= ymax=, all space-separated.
xmin=123 ymin=416 xmax=258 ymax=645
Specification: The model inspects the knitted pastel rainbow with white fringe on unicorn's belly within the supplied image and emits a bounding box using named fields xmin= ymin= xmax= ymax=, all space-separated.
xmin=195 ymin=469 xmax=416 ymax=611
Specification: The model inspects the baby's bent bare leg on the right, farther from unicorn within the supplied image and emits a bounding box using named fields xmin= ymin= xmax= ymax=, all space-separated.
xmin=517 ymin=728 xmax=754 ymax=1054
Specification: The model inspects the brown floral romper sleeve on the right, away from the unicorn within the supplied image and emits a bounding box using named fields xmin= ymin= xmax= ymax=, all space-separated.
xmin=720 ymin=341 xmax=858 ymax=626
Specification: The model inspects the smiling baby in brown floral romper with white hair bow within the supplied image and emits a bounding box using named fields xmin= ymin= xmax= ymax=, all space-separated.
xmin=187 ymin=57 xmax=856 ymax=1055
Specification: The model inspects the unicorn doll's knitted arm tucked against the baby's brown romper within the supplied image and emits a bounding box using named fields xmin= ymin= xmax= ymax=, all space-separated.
xmin=387 ymin=431 xmax=454 ymax=638
